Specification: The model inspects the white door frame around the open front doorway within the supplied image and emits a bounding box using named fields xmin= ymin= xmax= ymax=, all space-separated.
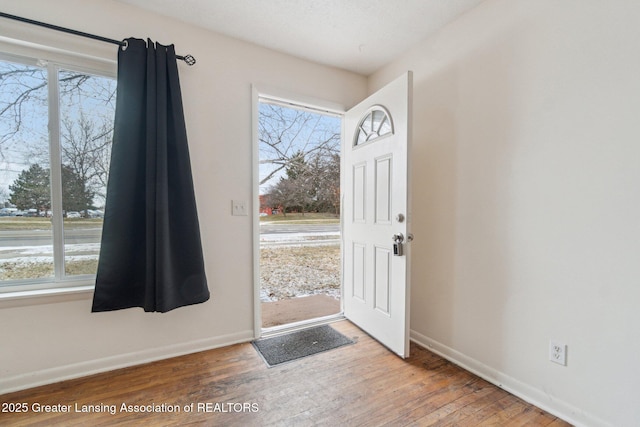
xmin=250 ymin=84 xmax=347 ymax=339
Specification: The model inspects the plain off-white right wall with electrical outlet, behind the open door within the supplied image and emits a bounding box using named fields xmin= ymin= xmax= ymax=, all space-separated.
xmin=370 ymin=0 xmax=640 ymax=426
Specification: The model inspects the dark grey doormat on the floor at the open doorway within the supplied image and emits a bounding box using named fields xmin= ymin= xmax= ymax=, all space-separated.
xmin=253 ymin=325 xmax=353 ymax=367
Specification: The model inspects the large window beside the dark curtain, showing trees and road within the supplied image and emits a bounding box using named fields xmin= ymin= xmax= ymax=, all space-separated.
xmin=0 ymin=51 xmax=116 ymax=292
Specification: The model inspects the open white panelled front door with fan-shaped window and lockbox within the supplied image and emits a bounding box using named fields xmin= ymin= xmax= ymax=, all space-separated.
xmin=342 ymin=72 xmax=412 ymax=357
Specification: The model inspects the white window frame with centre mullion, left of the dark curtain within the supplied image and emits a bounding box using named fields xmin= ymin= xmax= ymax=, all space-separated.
xmin=0 ymin=41 xmax=117 ymax=298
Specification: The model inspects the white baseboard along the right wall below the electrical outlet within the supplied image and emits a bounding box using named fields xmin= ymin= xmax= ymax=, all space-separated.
xmin=411 ymin=330 xmax=611 ymax=427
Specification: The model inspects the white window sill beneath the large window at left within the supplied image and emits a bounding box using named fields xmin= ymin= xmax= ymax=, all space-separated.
xmin=0 ymin=285 xmax=93 ymax=309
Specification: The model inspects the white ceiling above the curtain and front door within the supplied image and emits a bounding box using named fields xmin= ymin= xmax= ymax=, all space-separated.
xmin=117 ymin=0 xmax=483 ymax=75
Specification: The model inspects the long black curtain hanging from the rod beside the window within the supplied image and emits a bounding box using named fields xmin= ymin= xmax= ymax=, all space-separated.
xmin=92 ymin=39 xmax=209 ymax=312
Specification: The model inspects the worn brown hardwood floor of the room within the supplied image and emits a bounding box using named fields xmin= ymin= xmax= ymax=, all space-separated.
xmin=0 ymin=321 xmax=569 ymax=427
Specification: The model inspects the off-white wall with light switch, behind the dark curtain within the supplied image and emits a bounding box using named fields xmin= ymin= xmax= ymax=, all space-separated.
xmin=0 ymin=0 xmax=367 ymax=393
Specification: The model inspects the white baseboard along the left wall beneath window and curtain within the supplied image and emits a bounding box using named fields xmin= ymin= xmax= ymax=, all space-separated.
xmin=0 ymin=330 xmax=254 ymax=394
